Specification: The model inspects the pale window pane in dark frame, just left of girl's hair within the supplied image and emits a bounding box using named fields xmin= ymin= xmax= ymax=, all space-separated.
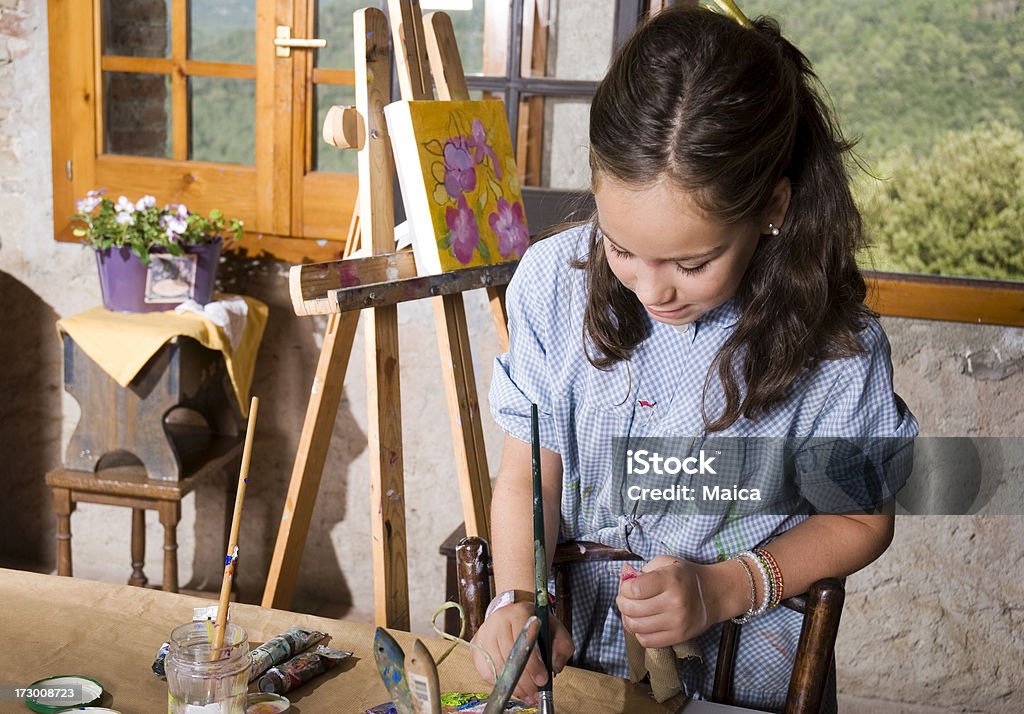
xmin=523 ymin=0 xmax=615 ymax=80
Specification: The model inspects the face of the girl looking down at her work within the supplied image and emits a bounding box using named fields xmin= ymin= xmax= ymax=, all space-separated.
xmin=594 ymin=176 xmax=788 ymax=325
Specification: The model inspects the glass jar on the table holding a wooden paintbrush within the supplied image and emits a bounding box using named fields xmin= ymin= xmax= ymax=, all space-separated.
xmin=164 ymin=622 xmax=252 ymax=714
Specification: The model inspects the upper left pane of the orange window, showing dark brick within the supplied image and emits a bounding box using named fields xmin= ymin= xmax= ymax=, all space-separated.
xmin=102 ymin=0 xmax=171 ymax=57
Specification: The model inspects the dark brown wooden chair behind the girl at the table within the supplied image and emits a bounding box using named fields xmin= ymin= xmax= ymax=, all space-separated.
xmin=456 ymin=537 xmax=846 ymax=714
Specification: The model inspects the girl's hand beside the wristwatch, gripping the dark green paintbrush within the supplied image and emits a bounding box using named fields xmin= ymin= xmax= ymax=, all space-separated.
xmin=473 ymin=602 xmax=575 ymax=706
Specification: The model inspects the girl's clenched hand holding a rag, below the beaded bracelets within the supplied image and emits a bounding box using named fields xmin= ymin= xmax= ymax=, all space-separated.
xmin=615 ymin=555 xmax=715 ymax=648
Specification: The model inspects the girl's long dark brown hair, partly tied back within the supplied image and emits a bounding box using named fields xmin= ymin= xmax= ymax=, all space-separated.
xmin=580 ymin=8 xmax=872 ymax=431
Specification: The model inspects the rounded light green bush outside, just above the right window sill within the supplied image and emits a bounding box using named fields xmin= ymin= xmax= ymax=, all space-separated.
xmin=857 ymin=123 xmax=1024 ymax=280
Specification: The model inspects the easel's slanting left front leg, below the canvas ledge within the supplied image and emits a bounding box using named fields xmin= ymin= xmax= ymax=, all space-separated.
xmin=262 ymin=312 xmax=359 ymax=610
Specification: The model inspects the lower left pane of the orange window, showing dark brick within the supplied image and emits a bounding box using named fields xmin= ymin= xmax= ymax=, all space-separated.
xmin=102 ymin=72 xmax=172 ymax=158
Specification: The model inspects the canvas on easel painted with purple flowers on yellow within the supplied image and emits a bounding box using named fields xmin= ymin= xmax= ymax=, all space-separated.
xmin=384 ymin=99 xmax=529 ymax=276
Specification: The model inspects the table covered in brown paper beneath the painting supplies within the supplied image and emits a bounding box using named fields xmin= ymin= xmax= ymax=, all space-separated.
xmin=0 ymin=569 xmax=746 ymax=714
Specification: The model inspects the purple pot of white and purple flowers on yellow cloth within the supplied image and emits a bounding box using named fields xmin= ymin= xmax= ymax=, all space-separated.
xmin=72 ymin=190 xmax=244 ymax=312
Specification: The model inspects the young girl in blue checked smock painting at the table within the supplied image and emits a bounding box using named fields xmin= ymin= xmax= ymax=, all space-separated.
xmin=475 ymin=8 xmax=916 ymax=709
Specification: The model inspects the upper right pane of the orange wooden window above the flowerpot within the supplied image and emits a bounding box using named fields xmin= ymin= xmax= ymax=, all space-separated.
xmin=188 ymin=0 xmax=256 ymax=65
